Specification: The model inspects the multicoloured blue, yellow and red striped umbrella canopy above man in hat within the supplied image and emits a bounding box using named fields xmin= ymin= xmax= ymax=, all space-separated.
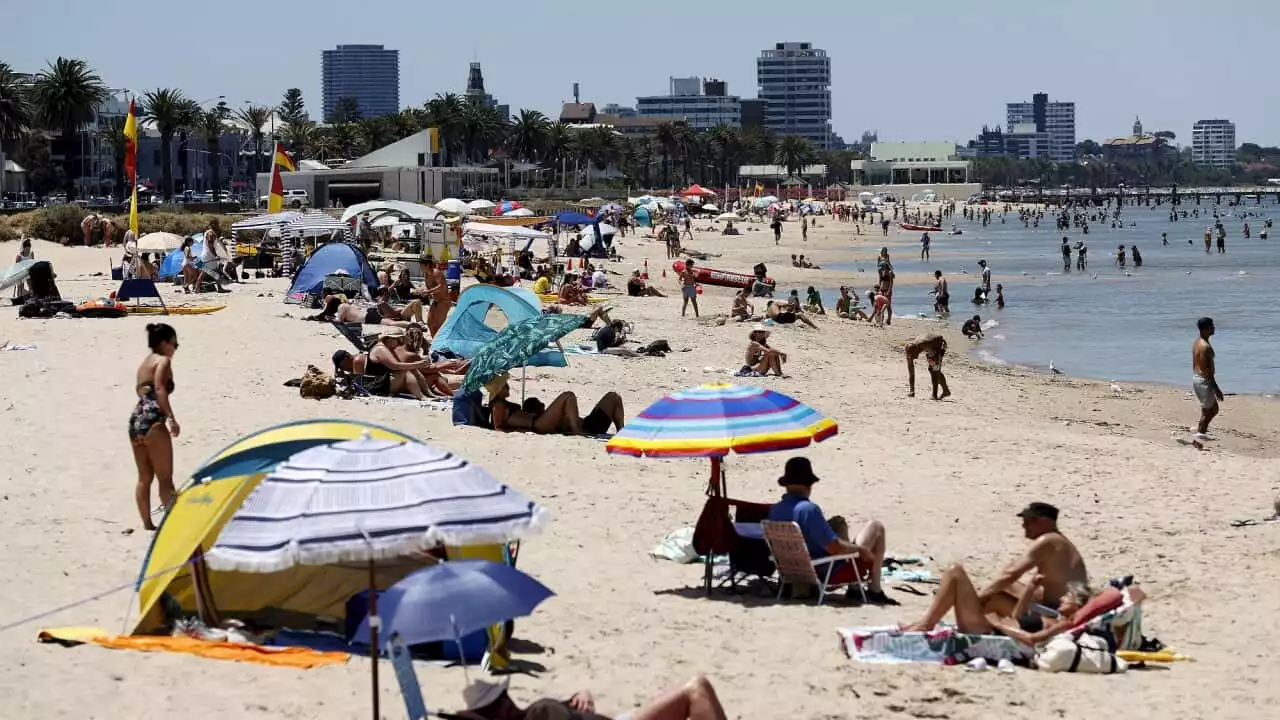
xmin=605 ymin=384 xmax=837 ymax=457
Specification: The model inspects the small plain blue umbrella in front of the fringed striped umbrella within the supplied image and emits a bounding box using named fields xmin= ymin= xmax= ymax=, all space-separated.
xmin=352 ymin=560 xmax=556 ymax=644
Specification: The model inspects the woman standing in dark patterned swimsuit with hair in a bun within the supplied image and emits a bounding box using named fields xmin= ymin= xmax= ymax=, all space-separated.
xmin=129 ymin=323 xmax=180 ymax=530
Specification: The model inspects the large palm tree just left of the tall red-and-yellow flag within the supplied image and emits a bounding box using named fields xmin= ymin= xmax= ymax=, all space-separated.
xmin=32 ymin=58 xmax=108 ymax=200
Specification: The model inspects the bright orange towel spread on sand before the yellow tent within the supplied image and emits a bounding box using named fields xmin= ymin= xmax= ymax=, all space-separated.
xmin=36 ymin=628 xmax=351 ymax=670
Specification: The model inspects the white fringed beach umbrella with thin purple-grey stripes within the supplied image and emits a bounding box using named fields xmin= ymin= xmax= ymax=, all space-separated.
xmin=205 ymin=437 xmax=549 ymax=573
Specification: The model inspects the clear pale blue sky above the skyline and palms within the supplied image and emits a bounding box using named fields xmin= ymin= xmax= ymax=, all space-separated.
xmin=10 ymin=0 xmax=1280 ymax=145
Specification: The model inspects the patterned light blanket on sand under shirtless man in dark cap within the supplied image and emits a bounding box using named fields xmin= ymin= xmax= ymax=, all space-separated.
xmin=836 ymin=625 xmax=1032 ymax=665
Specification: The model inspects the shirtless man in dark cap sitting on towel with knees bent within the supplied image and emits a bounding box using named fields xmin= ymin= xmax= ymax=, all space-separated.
xmin=902 ymin=502 xmax=1089 ymax=633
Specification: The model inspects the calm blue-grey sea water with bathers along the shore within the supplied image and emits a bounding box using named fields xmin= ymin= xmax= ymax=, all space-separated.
xmin=824 ymin=199 xmax=1280 ymax=395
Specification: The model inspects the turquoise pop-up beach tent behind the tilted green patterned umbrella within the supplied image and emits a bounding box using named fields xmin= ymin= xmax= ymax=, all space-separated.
xmin=431 ymin=284 xmax=567 ymax=368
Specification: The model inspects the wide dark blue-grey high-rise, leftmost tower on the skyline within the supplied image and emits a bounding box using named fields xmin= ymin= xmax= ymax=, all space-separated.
xmin=321 ymin=45 xmax=399 ymax=120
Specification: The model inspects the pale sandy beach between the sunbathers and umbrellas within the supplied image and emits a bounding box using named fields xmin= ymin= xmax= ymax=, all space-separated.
xmin=0 ymin=218 xmax=1280 ymax=720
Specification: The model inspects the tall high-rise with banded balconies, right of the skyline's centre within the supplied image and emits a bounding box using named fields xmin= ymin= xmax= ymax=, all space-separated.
xmin=755 ymin=42 xmax=832 ymax=150
